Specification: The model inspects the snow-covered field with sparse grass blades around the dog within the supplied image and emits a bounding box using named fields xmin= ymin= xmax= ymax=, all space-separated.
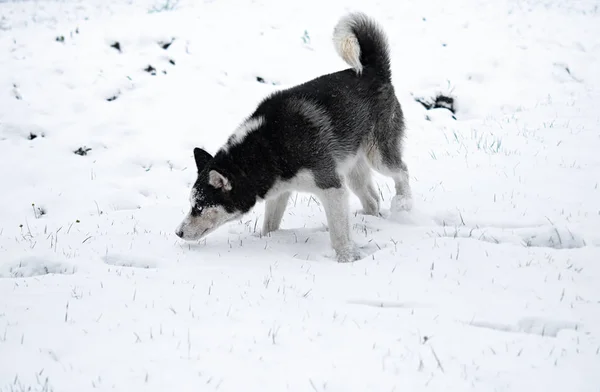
xmin=0 ymin=0 xmax=600 ymax=392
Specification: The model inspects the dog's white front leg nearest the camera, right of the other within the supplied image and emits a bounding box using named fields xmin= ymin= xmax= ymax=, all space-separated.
xmin=318 ymin=186 xmax=361 ymax=263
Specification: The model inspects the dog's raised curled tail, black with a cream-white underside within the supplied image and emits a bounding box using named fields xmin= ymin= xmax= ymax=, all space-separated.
xmin=333 ymin=12 xmax=392 ymax=81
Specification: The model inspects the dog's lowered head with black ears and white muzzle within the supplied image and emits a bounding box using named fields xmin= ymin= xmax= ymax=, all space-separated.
xmin=175 ymin=148 xmax=255 ymax=241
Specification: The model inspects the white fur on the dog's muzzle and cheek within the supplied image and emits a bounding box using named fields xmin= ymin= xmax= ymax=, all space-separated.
xmin=175 ymin=188 xmax=242 ymax=241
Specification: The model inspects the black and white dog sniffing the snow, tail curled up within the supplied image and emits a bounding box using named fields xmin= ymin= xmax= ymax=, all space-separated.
xmin=176 ymin=13 xmax=412 ymax=262
